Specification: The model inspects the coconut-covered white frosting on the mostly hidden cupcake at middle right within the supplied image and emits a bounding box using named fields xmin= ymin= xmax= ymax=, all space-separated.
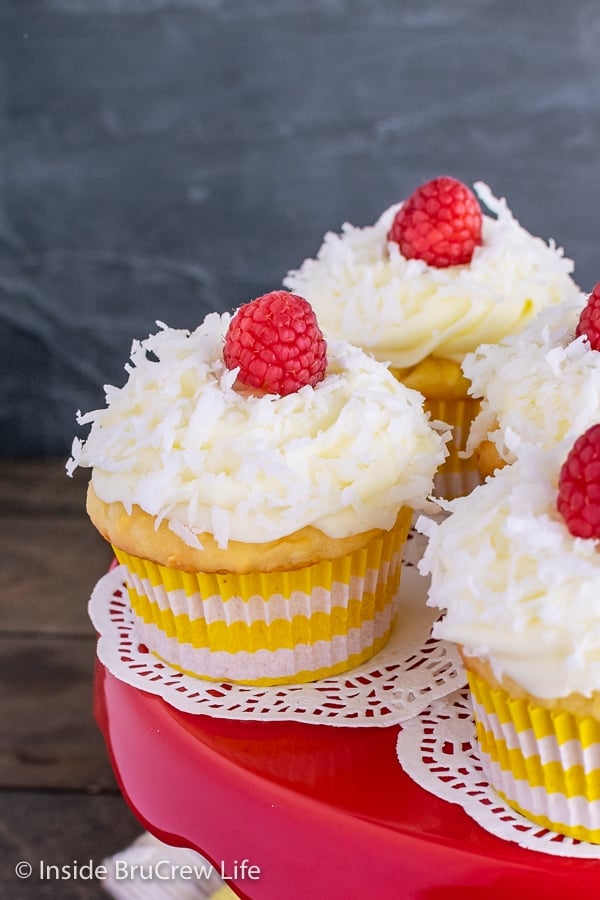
xmin=463 ymin=295 xmax=600 ymax=462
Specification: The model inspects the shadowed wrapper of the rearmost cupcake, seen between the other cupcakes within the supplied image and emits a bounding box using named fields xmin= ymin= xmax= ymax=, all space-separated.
xmin=424 ymin=397 xmax=482 ymax=500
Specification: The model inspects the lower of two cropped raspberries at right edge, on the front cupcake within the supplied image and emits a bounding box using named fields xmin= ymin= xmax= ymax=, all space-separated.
xmin=556 ymin=424 xmax=600 ymax=538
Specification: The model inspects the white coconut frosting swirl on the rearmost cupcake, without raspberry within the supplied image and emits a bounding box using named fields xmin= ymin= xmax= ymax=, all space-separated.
xmin=284 ymin=183 xmax=579 ymax=368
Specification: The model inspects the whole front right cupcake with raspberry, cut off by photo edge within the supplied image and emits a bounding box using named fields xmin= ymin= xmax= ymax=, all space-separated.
xmin=417 ymin=438 xmax=600 ymax=843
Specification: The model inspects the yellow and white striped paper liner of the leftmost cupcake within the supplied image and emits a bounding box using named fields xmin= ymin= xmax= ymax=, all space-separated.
xmin=114 ymin=509 xmax=412 ymax=686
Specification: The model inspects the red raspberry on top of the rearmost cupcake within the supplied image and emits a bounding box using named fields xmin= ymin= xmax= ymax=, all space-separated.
xmin=388 ymin=176 xmax=482 ymax=269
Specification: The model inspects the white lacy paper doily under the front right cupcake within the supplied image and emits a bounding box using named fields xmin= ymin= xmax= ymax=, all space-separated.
xmin=396 ymin=688 xmax=600 ymax=859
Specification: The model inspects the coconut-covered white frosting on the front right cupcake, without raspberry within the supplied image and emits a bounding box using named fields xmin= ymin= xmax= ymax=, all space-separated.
xmin=417 ymin=445 xmax=600 ymax=698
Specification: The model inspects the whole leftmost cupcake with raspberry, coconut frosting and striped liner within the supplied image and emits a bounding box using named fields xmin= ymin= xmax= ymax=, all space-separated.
xmin=68 ymin=291 xmax=447 ymax=685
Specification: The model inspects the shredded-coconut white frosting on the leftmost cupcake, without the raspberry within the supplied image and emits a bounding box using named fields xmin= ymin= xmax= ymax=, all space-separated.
xmin=68 ymin=313 xmax=447 ymax=546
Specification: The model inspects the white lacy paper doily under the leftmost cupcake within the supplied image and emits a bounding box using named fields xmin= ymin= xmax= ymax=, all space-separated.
xmin=89 ymin=532 xmax=465 ymax=726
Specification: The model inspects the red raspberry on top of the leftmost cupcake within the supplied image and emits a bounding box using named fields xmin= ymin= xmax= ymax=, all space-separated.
xmin=223 ymin=291 xmax=327 ymax=396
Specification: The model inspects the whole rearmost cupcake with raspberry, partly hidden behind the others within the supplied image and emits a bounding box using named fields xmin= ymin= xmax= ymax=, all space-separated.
xmin=284 ymin=177 xmax=579 ymax=497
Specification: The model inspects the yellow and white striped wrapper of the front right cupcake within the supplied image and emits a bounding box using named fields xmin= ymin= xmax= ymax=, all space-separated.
xmin=468 ymin=671 xmax=600 ymax=844
